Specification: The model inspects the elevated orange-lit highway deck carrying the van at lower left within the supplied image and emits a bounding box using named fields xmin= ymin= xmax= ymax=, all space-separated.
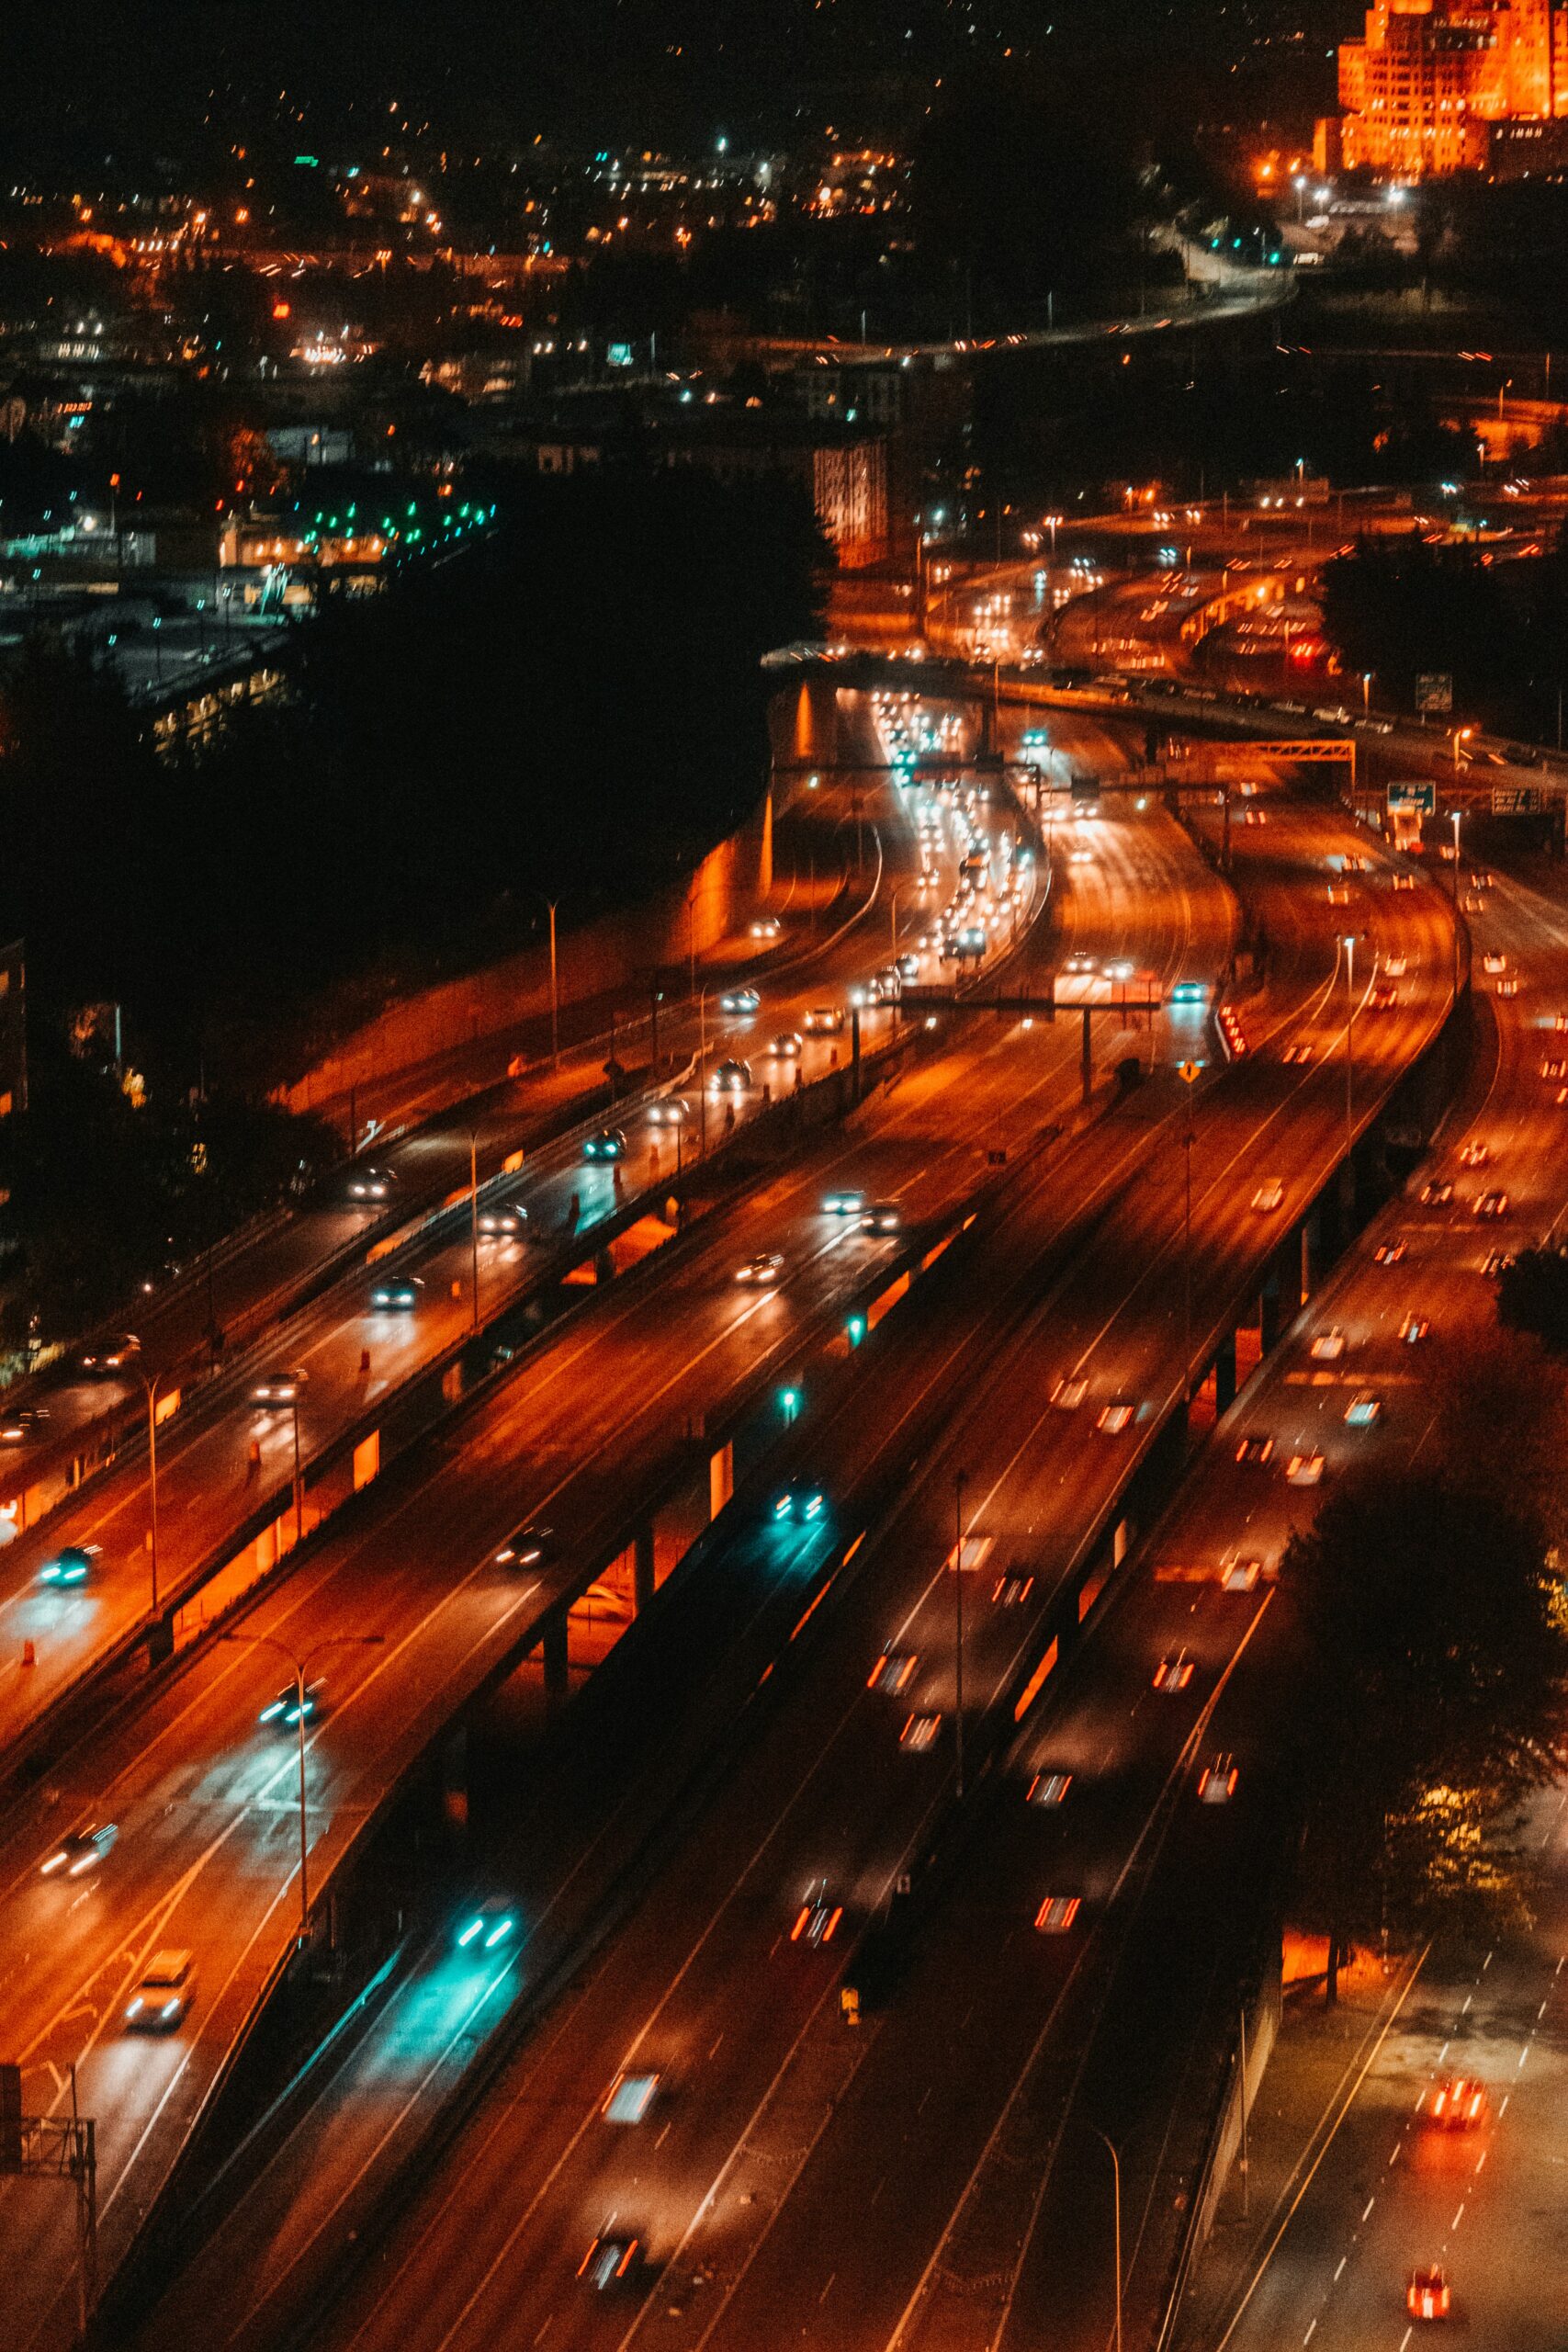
xmin=0 ymin=686 xmax=1229 ymax=2340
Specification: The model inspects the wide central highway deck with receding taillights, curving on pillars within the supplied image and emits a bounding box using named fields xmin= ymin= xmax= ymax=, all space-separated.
xmin=169 ymin=786 xmax=1448 ymax=2345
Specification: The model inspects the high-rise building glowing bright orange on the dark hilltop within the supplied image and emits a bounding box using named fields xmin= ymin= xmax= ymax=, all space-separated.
xmin=1319 ymin=0 xmax=1568 ymax=179
